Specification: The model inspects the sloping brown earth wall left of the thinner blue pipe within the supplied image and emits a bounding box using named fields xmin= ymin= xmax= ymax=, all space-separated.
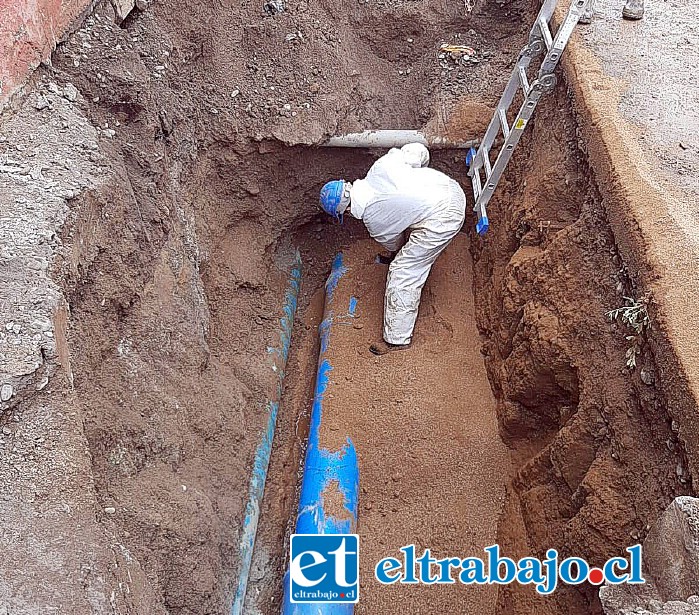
xmin=56 ymin=138 xmax=378 ymax=613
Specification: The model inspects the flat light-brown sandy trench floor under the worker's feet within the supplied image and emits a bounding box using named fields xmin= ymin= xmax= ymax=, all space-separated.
xmin=252 ymin=234 xmax=509 ymax=614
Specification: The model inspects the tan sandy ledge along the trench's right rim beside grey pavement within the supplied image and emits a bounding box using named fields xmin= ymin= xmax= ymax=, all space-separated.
xmin=564 ymin=28 xmax=699 ymax=508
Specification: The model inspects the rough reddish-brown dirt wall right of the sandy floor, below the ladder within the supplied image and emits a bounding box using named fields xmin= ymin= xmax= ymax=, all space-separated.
xmin=473 ymin=86 xmax=692 ymax=614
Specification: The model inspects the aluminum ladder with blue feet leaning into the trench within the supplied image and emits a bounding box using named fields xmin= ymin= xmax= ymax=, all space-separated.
xmin=466 ymin=0 xmax=588 ymax=235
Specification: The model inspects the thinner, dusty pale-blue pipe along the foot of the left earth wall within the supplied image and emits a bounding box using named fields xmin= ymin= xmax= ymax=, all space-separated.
xmin=231 ymin=251 xmax=301 ymax=615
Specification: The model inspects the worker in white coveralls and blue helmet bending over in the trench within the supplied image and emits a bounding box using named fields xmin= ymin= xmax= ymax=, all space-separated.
xmin=320 ymin=143 xmax=466 ymax=355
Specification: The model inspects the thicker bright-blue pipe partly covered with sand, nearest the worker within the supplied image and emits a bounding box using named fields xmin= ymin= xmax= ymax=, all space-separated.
xmin=282 ymin=253 xmax=359 ymax=615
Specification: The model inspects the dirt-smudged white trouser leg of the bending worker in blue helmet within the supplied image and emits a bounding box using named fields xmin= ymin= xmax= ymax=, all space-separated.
xmin=383 ymin=186 xmax=466 ymax=344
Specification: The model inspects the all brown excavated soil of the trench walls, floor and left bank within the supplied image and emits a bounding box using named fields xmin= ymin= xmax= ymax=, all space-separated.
xmin=0 ymin=0 xmax=693 ymax=615
